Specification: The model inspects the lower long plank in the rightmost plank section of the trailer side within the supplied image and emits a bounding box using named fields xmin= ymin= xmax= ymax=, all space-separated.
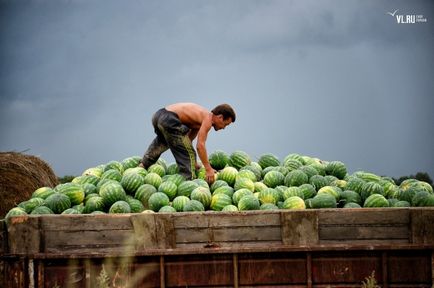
xmin=319 ymin=225 xmax=409 ymax=243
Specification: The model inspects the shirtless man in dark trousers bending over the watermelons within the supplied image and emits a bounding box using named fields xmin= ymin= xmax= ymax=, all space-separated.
xmin=140 ymin=103 xmax=236 ymax=184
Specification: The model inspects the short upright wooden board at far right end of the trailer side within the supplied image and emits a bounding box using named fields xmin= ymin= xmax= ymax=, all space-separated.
xmin=411 ymin=208 xmax=434 ymax=244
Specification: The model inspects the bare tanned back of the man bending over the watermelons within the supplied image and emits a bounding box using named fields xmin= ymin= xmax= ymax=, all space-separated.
xmin=166 ymin=103 xmax=211 ymax=130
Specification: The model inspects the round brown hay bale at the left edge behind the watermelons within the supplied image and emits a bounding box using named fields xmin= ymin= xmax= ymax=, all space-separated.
xmin=0 ymin=152 xmax=58 ymax=219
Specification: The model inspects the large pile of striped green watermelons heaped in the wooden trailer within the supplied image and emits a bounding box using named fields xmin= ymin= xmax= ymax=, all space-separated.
xmin=6 ymin=150 xmax=434 ymax=218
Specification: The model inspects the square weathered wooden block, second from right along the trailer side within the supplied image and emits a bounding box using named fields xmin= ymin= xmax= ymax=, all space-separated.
xmin=281 ymin=210 xmax=319 ymax=245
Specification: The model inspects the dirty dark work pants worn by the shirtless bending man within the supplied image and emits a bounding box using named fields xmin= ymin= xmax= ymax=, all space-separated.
xmin=142 ymin=108 xmax=196 ymax=179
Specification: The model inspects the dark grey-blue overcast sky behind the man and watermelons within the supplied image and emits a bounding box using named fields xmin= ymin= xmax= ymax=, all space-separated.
xmin=0 ymin=0 xmax=434 ymax=178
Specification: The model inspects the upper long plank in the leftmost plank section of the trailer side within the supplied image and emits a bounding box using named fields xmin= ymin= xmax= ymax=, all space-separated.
xmin=39 ymin=214 xmax=133 ymax=231
